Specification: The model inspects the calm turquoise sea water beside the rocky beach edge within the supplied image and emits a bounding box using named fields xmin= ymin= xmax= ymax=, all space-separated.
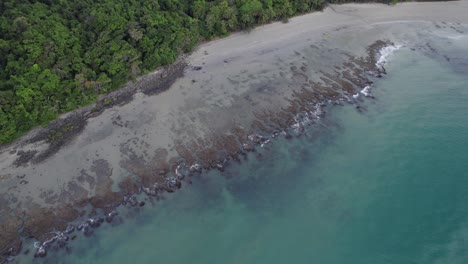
xmin=26 ymin=46 xmax=468 ymax=264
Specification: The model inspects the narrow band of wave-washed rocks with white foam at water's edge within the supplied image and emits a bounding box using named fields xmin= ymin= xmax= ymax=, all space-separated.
xmin=28 ymin=41 xmax=398 ymax=257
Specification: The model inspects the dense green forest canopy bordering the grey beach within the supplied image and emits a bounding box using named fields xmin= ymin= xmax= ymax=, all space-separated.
xmin=0 ymin=0 xmax=400 ymax=143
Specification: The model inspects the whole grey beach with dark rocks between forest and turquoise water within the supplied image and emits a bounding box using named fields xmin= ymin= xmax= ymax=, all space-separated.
xmin=0 ymin=1 xmax=468 ymax=254
